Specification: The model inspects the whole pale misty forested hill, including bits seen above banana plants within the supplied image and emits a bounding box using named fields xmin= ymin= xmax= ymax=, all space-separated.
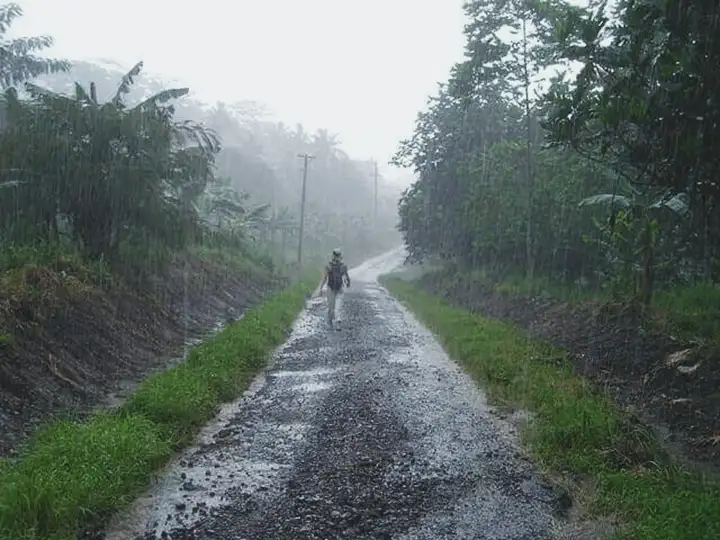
xmin=38 ymin=62 xmax=400 ymax=260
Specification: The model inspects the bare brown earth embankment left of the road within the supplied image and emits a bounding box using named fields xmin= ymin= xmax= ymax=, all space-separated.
xmin=0 ymin=255 xmax=282 ymax=456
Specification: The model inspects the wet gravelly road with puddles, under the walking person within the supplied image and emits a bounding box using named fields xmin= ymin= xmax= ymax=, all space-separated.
xmin=107 ymin=252 xmax=559 ymax=540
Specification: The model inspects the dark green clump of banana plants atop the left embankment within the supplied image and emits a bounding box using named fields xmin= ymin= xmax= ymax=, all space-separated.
xmin=0 ymin=62 xmax=219 ymax=259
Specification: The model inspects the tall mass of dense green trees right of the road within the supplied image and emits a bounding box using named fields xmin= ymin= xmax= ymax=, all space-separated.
xmin=396 ymin=0 xmax=720 ymax=304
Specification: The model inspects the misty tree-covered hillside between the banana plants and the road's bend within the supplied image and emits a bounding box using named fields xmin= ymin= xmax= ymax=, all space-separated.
xmin=182 ymin=103 xmax=400 ymax=257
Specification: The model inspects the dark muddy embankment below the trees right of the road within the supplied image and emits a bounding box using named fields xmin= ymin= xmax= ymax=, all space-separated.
xmin=416 ymin=272 xmax=720 ymax=470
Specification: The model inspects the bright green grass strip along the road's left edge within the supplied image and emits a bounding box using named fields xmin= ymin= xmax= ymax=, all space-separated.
xmin=0 ymin=280 xmax=315 ymax=540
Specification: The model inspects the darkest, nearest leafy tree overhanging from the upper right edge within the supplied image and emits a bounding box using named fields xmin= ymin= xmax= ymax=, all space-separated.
xmin=545 ymin=0 xmax=720 ymax=279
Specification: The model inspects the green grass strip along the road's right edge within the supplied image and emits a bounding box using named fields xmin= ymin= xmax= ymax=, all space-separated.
xmin=382 ymin=277 xmax=720 ymax=540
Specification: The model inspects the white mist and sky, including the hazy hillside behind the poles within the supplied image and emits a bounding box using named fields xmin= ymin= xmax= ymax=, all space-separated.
xmin=9 ymin=0 xmax=470 ymax=257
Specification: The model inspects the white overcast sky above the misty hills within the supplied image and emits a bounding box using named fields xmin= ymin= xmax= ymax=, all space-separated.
xmin=12 ymin=0 xmax=464 ymax=182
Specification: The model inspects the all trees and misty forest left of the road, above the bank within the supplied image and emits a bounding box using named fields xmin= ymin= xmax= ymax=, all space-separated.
xmin=0 ymin=4 xmax=396 ymax=274
